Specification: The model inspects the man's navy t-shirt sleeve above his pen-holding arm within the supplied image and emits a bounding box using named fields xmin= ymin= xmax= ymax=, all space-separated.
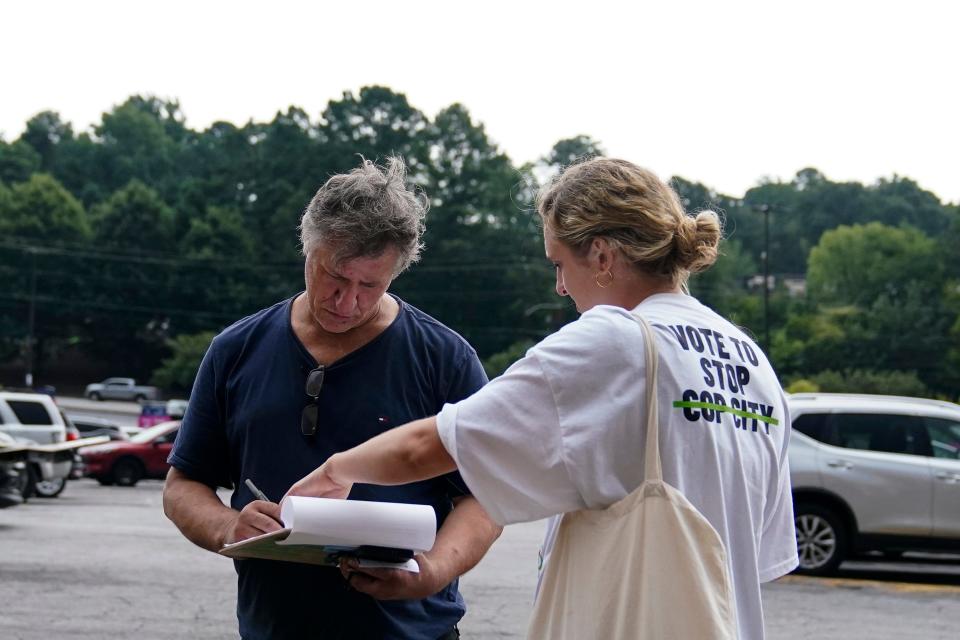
xmin=167 ymin=338 xmax=233 ymax=488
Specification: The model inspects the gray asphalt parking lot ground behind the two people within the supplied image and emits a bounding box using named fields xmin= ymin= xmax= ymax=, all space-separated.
xmin=0 ymin=480 xmax=960 ymax=640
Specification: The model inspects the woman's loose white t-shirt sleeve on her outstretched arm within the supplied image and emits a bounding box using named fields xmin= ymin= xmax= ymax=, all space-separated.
xmin=437 ymin=354 xmax=583 ymax=525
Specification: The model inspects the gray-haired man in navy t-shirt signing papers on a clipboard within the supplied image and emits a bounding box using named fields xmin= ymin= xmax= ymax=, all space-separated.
xmin=163 ymin=158 xmax=500 ymax=640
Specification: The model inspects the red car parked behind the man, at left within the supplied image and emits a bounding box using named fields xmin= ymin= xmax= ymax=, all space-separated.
xmin=80 ymin=422 xmax=180 ymax=487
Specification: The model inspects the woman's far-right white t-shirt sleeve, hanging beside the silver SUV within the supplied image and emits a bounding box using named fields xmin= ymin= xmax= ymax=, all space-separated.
xmin=757 ymin=390 xmax=799 ymax=582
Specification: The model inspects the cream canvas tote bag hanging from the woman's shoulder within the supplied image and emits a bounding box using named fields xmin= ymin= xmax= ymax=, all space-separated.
xmin=527 ymin=314 xmax=737 ymax=640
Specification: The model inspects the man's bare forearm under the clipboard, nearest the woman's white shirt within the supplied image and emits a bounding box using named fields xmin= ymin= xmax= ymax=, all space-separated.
xmin=429 ymin=496 xmax=503 ymax=587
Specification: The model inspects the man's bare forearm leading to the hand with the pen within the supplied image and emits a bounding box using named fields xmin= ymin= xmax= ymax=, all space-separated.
xmin=163 ymin=468 xmax=239 ymax=551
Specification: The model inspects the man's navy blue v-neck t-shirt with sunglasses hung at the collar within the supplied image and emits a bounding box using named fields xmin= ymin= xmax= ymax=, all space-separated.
xmin=169 ymin=299 xmax=487 ymax=640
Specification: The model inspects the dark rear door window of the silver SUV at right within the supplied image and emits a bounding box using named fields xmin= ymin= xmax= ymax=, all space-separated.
xmin=828 ymin=413 xmax=930 ymax=456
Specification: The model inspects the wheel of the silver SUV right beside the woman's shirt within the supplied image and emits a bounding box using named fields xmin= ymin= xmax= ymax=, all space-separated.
xmin=793 ymin=503 xmax=847 ymax=576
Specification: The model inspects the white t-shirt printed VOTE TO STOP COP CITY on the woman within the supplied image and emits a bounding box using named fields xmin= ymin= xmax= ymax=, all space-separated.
xmin=437 ymin=294 xmax=797 ymax=640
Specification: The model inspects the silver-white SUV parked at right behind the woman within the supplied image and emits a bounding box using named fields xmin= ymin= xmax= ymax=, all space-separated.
xmin=788 ymin=393 xmax=960 ymax=574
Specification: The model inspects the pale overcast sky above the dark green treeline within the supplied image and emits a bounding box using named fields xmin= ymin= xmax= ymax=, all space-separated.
xmin=0 ymin=0 xmax=960 ymax=202
